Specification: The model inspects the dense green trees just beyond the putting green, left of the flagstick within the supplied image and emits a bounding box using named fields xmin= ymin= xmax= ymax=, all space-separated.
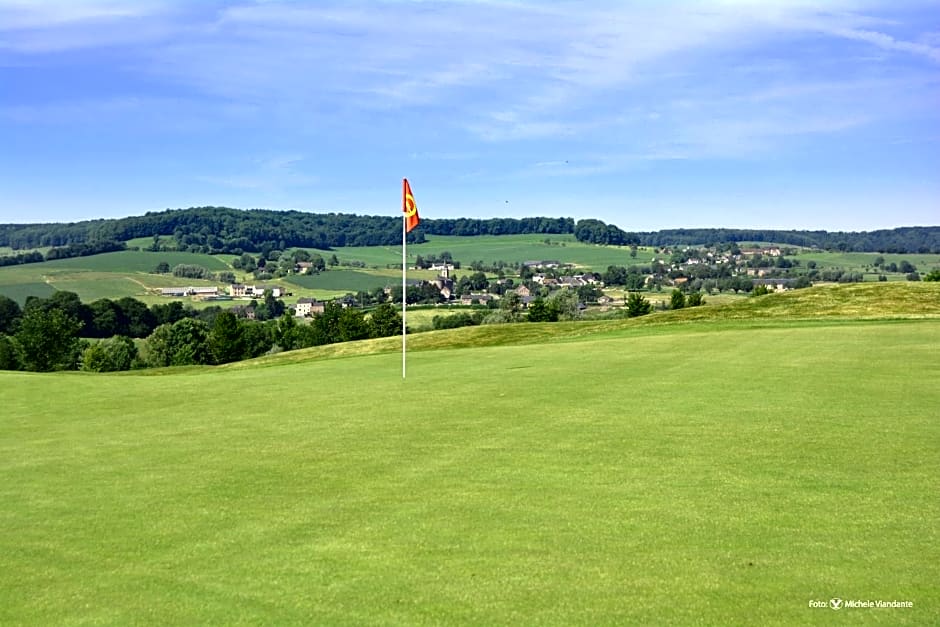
xmin=0 ymin=291 xmax=402 ymax=372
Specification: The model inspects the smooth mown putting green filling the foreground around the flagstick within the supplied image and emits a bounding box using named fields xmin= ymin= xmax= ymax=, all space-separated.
xmin=0 ymin=319 xmax=940 ymax=625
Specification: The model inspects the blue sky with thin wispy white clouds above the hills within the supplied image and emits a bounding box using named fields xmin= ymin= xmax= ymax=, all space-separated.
xmin=0 ymin=0 xmax=940 ymax=230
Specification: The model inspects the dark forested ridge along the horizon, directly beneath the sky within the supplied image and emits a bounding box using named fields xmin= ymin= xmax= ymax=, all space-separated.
xmin=0 ymin=207 xmax=940 ymax=258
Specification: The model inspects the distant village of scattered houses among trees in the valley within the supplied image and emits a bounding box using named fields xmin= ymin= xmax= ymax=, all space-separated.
xmin=159 ymin=244 xmax=812 ymax=318
